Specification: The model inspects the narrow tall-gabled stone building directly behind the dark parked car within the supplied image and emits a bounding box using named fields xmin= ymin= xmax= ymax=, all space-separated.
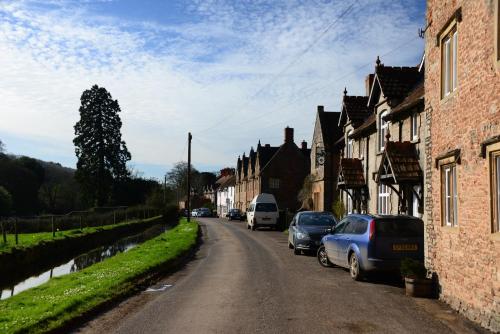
xmin=311 ymin=106 xmax=343 ymax=211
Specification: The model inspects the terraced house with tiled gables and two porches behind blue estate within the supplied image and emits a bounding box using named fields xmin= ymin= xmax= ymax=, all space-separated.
xmin=337 ymin=58 xmax=425 ymax=217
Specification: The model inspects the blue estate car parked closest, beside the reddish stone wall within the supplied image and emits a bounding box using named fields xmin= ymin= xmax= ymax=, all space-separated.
xmin=317 ymin=214 xmax=424 ymax=280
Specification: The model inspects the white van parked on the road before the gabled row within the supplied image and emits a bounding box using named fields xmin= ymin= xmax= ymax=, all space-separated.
xmin=247 ymin=194 xmax=279 ymax=231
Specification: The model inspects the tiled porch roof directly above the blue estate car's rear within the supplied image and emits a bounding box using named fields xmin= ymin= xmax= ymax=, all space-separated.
xmin=377 ymin=141 xmax=423 ymax=184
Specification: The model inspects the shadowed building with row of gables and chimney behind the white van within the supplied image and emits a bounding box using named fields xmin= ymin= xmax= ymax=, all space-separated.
xmin=235 ymin=127 xmax=311 ymax=211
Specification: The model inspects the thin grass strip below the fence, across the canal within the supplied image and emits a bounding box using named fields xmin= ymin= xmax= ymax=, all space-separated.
xmin=0 ymin=216 xmax=159 ymax=254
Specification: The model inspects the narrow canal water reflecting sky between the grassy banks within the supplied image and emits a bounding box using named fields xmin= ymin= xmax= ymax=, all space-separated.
xmin=0 ymin=225 xmax=167 ymax=300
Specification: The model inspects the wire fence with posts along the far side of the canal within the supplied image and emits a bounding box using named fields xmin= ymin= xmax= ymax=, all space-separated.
xmin=0 ymin=206 xmax=164 ymax=244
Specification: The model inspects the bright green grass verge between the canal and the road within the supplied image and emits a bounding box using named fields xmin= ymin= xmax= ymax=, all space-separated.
xmin=0 ymin=220 xmax=198 ymax=333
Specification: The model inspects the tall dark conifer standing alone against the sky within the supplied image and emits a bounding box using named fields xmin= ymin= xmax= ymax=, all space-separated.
xmin=73 ymin=85 xmax=131 ymax=206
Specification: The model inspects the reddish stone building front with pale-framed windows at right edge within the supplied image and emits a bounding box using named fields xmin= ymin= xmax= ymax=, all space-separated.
xmin=425 ymin=0 xmax=500 ymax=331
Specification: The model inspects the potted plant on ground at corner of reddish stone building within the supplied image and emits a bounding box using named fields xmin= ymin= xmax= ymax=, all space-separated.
xmin=400 ymin=258 xmax=433 ymax=298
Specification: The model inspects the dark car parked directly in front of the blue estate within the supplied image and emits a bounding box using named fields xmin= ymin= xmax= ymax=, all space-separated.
xmin=288 ymin=211 xmax=337 ymax=255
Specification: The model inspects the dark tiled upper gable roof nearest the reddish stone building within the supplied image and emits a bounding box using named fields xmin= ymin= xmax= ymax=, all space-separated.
xmin=375 ymin=65 xmax=423 ymax=99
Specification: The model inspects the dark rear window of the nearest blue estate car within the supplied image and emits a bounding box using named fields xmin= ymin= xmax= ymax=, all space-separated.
xmin=375 ymin=219 xmax=424 ymax=238
